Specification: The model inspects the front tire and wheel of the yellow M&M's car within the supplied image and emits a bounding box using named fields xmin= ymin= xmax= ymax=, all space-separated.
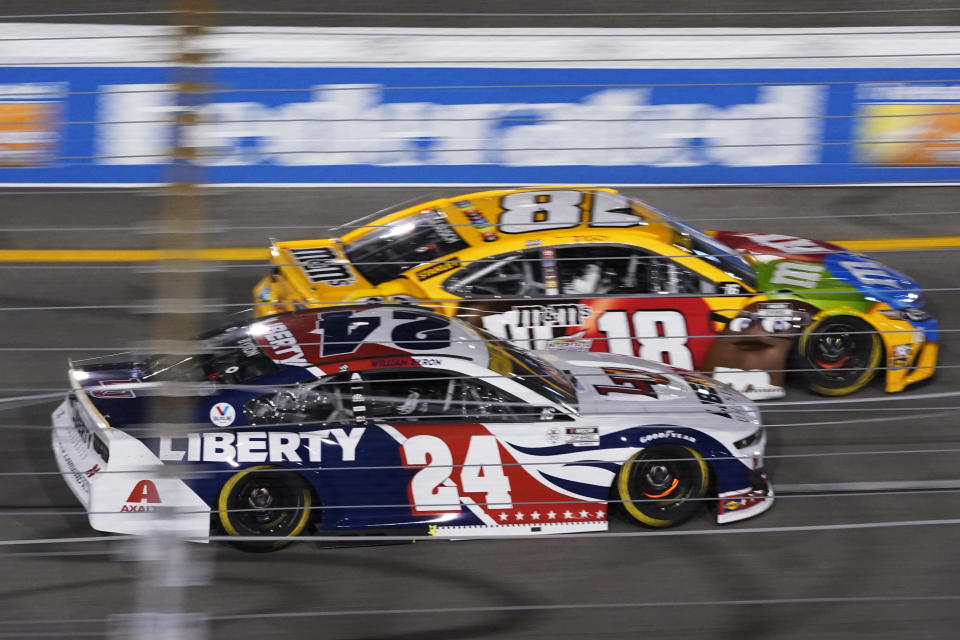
xmin=797 ymin=315 xmax=883 ymax=396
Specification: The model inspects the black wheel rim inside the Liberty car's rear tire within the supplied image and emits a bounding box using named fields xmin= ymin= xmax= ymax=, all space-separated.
xmin=230 ymin=474 xmax=305 ymax=536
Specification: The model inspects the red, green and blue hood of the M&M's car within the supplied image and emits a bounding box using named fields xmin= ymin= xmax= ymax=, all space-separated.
xmin=714 ymin=231 xmax=921 ymax=309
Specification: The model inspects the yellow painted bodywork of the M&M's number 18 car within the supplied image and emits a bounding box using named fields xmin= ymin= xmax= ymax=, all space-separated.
xmin=254 ymin=186 xmax=936 ymax=392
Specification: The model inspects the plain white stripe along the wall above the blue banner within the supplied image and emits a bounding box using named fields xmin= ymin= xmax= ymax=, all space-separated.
xmin=0 ymin=22 xmax=960 ymax=68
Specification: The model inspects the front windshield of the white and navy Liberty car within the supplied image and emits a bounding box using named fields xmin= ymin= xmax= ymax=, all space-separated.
xmin=475 ymin=328 xmax=577 ymax=411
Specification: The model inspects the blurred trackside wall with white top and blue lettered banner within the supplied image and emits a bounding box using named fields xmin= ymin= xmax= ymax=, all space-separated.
xmin=0 ymin=25 xmax=960 ymax=185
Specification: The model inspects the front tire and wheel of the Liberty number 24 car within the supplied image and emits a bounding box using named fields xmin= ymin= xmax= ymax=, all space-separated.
xmin=615 ymin=444 xmax=710 ymax=529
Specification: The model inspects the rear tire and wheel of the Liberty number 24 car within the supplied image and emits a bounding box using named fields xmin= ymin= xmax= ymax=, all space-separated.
xmin=217 ymin=465 xmax=313 ymax=553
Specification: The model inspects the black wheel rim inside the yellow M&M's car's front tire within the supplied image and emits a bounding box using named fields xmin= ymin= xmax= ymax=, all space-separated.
xmin=808 ymin=322 xmax=874 ymax=387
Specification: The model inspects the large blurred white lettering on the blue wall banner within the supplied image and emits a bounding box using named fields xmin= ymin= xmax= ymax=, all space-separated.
xmin=96 ymin=84 xmax=826 ymax=167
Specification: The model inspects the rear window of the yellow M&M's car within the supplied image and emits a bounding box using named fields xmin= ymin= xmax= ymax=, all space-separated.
xmin=344 ymin=209 xmax=468 ymax=285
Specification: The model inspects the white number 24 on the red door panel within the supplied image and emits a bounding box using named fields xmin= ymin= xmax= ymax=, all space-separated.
xmin=400 ymin=435 xmax=513 ymax=514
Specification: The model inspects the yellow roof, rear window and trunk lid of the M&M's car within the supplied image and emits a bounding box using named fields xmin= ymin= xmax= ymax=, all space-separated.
xmin=273 ymin=187 xmax=686 ymax=293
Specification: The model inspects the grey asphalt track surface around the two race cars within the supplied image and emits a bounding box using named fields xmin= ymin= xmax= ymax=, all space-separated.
xmin=0 ymin=182 xmax=960 ymax=639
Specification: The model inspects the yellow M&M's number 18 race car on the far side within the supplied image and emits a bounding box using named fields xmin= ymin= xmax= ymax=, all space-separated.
xmin=254 ymin=187 xmax=937 ymax=398
